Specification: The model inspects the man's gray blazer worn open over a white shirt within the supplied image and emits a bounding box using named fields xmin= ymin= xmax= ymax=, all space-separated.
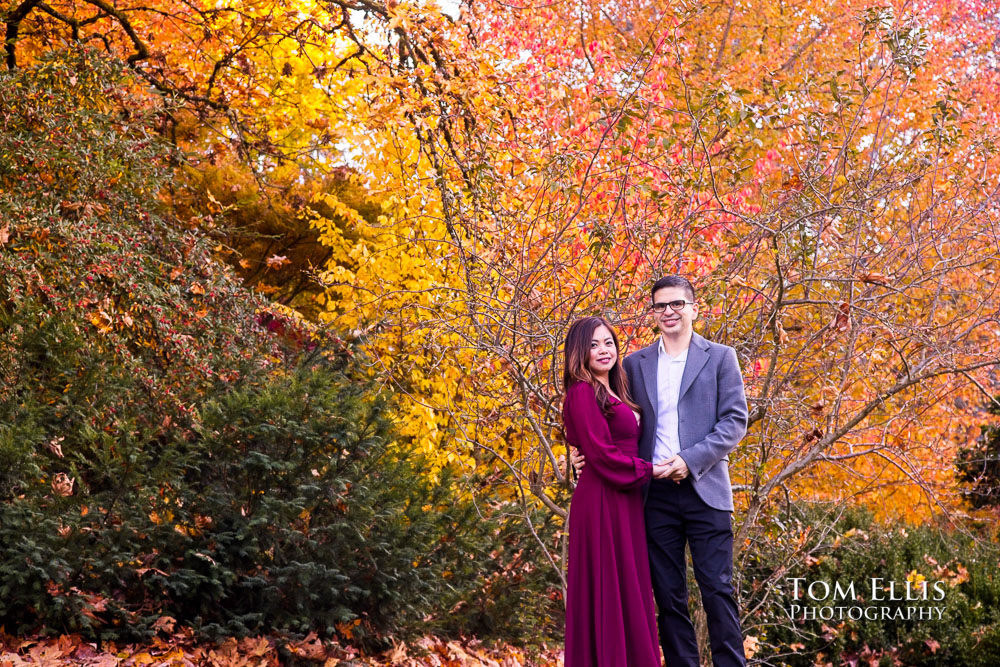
xmin=622 ymin=334 xmax=747 ymax=512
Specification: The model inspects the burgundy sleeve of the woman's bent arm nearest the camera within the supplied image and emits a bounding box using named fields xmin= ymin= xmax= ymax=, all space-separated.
xmin=563 ymin=382 xmax=653 ymax=489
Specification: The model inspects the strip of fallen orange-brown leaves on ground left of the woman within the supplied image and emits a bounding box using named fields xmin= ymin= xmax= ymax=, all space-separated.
xmin=0 ymin=632 xmax=563 ymax=667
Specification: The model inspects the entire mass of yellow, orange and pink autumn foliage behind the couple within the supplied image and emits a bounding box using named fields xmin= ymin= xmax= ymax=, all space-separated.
xmin=6 ymin=0 xmax=997 ymax=616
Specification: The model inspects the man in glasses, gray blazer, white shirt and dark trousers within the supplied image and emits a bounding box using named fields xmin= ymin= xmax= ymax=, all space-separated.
xmin=574 ymin=276 xmax=747 ymax=667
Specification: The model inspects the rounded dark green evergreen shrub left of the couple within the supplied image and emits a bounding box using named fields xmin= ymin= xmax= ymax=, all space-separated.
xmin=166 ymin=370 xmax=516 ymax=636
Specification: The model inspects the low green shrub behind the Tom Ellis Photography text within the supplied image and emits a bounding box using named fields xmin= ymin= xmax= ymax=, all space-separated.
xmin=742 ymin=510 xmax=1000 ymax=667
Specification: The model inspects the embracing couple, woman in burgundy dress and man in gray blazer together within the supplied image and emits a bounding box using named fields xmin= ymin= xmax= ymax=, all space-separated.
xmin=563 ymin=276 xmax=747 ymax=667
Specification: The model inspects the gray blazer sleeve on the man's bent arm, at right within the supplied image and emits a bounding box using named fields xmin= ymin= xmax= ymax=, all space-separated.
xmin=680 ymin=347 xmax=749 ymax=480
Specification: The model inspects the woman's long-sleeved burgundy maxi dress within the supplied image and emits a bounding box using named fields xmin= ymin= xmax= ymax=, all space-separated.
xmin=563 ymin=382 xmax=660 ymax=667
